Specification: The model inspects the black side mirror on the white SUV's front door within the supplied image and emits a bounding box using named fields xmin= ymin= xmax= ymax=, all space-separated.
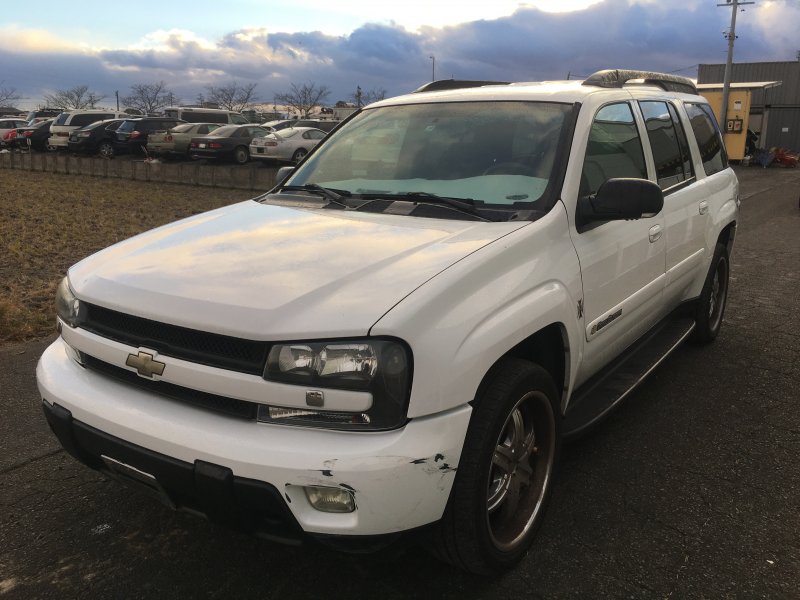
xmin=576 ymin=178 xmax=664 ymax=229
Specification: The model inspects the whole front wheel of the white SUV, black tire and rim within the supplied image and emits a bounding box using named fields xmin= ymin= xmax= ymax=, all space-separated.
xmin=432 ymin=358 xmax=561 ymax=575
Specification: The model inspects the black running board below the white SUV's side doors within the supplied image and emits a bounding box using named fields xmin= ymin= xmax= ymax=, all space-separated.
xmin=563 ymin=316 xmax=694 ymax=438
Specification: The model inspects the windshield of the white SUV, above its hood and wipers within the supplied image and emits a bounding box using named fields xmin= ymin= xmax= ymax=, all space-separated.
xmin=287 ymin=102 xmax=571 ymax=210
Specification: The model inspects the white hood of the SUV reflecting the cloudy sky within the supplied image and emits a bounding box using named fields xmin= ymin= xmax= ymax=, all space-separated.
xmin=69 ymin=201 xmax=526 ymax=340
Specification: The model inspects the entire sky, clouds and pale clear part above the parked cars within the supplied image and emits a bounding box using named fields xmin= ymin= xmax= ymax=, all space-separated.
xmin=0 ymin=0 xmax=800 ymax=109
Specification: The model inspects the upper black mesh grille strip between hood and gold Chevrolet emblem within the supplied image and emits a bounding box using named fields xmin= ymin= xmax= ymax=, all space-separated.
xmin=80 ymin=303 xmax=269 ymax=376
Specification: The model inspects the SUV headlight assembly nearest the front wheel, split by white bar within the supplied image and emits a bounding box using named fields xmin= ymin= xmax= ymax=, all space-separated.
xmin=259 ymin=339 xmax=411 ymax=430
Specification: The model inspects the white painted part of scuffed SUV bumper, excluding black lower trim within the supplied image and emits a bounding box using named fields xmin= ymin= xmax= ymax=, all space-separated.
xmin=36 ymin=338 xmax=471 ymax=535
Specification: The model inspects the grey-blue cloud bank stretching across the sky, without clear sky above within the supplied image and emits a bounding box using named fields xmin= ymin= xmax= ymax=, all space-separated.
xmin=0 ymin=0 xmax=800 ymax=110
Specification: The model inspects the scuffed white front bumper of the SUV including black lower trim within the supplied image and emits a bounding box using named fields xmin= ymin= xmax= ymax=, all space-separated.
xmin=37 ymin=338 xmax=471 ymax=537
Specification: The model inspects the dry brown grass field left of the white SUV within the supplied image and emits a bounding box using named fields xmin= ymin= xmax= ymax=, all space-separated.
xmin=0 ymin=170 xmax=255 ymax=343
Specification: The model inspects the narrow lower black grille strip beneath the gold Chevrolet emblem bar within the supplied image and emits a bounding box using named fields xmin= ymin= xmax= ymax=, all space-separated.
xmin=83 ymin=355 xmax=258 ymax=421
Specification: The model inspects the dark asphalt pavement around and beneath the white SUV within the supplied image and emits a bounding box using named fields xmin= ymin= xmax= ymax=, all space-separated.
xmin=0 ymin=168 xmax=800 ymax=600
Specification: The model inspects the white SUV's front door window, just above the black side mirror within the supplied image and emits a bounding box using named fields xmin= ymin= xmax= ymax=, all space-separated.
xmin=580 ymin=103 xmax=647 ymax=196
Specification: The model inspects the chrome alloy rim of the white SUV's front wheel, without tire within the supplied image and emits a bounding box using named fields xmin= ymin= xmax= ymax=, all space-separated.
xmin=486 ymin=391 xmax=556 ymax=551
